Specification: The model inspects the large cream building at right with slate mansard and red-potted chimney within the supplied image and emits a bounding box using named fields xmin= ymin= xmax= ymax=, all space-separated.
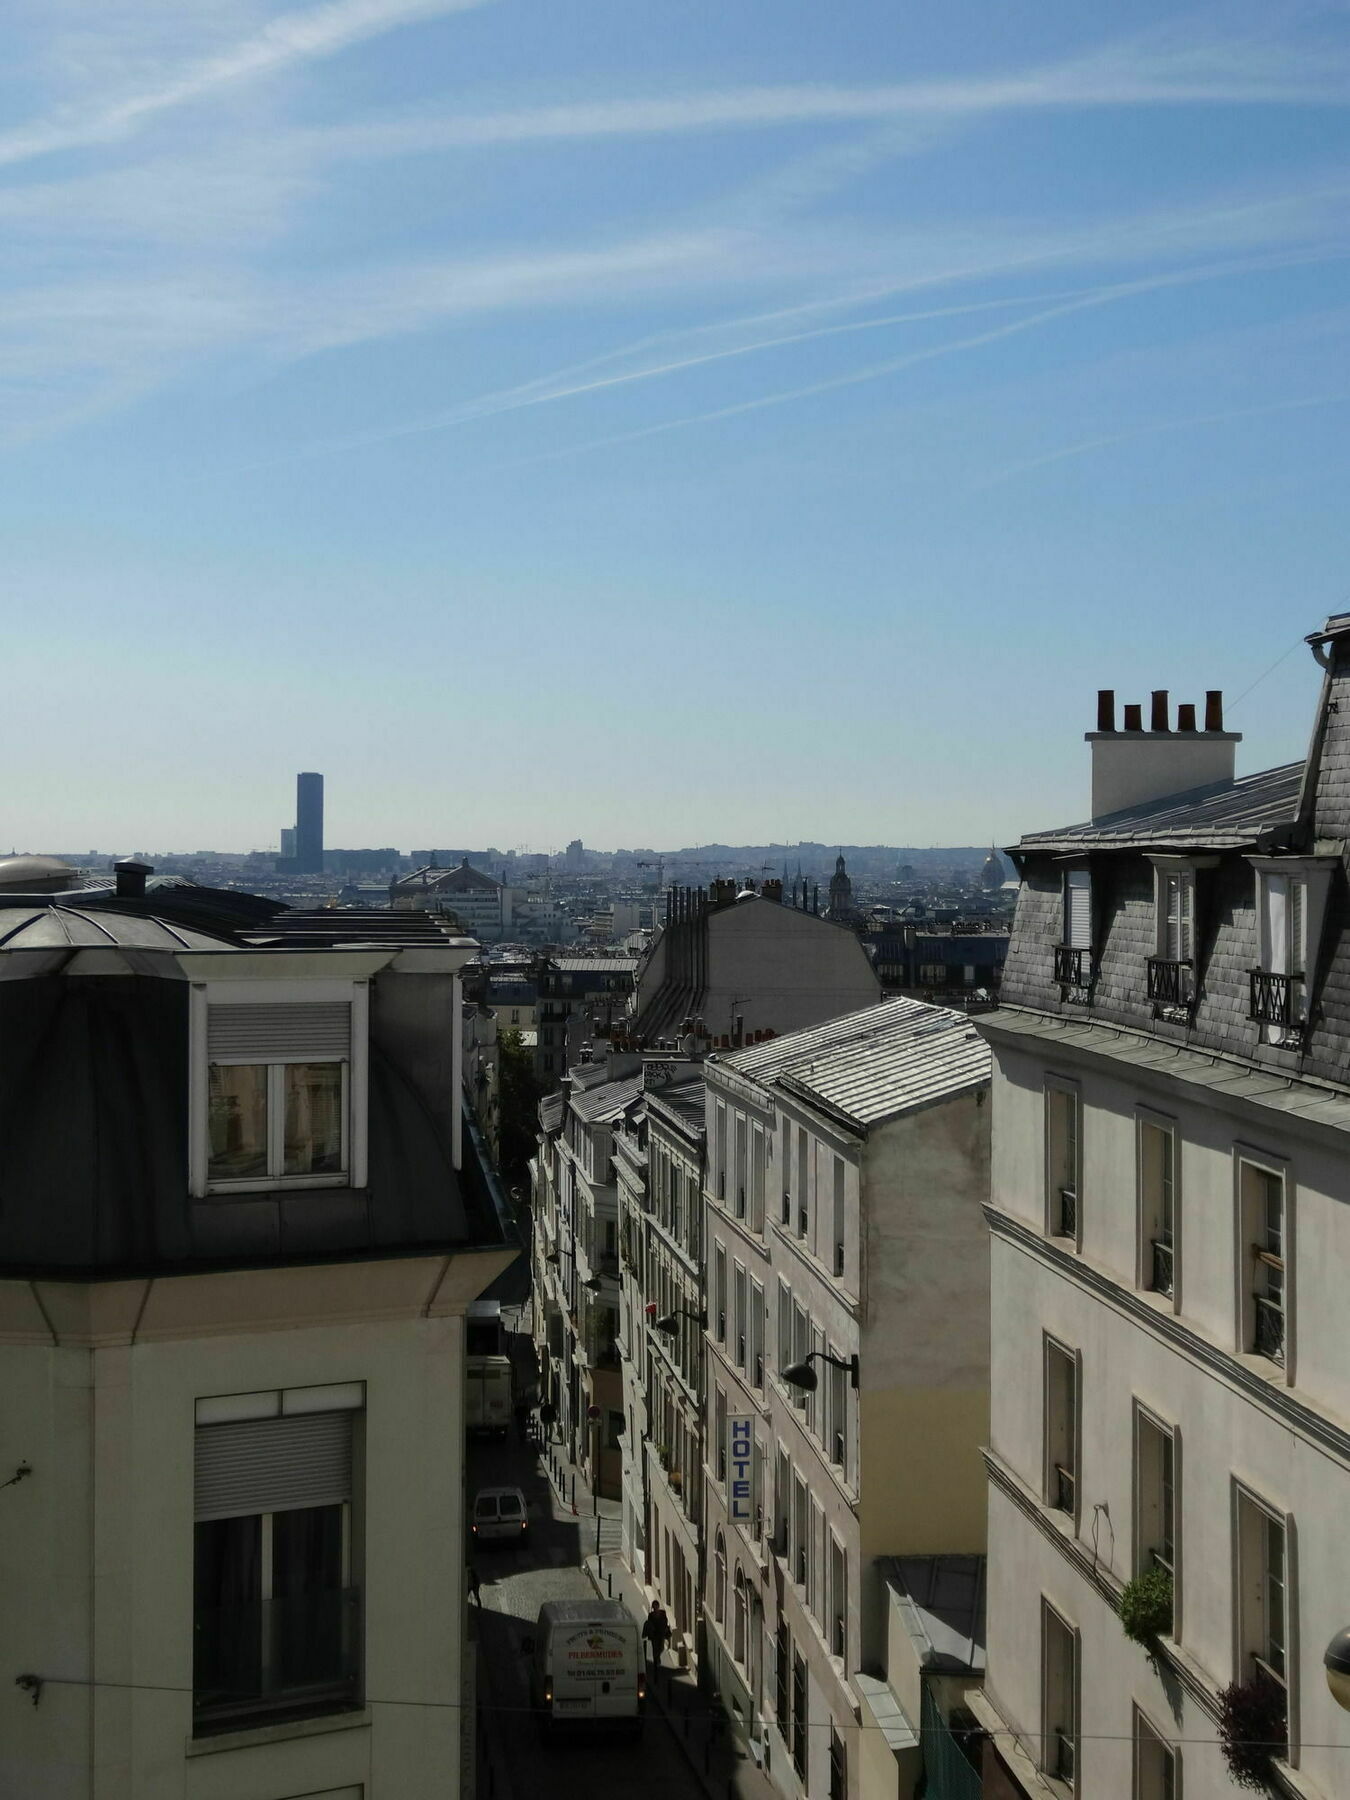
xmin=976 ymin=662 xmax=1350 ymax=1800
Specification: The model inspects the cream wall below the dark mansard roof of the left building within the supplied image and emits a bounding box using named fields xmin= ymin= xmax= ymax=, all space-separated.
xmin=0 ymin=1265 xmax=490 ymax=1800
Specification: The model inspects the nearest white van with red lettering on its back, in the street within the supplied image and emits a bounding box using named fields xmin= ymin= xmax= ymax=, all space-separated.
xmin=529 ymin=1600 xmax=646 ymax=1735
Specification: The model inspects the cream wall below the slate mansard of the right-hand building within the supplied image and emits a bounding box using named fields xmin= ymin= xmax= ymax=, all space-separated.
xmin=988 ymin=1048 xmax=1350 ymax=1800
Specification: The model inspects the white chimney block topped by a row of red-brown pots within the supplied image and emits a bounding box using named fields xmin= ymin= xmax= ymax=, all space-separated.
xmin=1085 ymin=688 xmax=1242 ymax=821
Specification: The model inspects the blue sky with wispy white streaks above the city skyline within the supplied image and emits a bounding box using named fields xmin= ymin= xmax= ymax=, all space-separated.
xmin=0 ymin=0 xmax=1350 ymax=848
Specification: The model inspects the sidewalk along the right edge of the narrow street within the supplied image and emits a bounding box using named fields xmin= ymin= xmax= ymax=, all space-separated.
xmin=542 ymin=1444 xmax=770 ymax=1800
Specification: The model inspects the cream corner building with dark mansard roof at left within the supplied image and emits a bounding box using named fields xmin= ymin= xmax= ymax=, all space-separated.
xmin=0 ymin=866 xmax=513 ymax=1800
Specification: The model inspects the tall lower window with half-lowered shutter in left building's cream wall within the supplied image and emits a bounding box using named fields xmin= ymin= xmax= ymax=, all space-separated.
xmin=193 ymin=1382 xmax=364 ymax=1735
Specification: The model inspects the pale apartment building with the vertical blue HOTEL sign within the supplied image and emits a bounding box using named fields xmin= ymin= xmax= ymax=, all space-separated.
xmin=704 ymin=999 xmax=990 ymax=1800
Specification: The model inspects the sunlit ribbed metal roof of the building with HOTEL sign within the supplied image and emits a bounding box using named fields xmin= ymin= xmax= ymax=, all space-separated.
xmin=718 ymin=999 xmax=992 ymax=1130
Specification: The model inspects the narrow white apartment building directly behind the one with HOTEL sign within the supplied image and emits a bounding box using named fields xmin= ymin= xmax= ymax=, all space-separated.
xmin=616 ymin=1058 xmax=704 ymax=1658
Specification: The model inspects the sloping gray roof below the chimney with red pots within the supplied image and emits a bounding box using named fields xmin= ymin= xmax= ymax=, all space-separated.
xmin=1017 ymin=761 xmax=1303 ymax=851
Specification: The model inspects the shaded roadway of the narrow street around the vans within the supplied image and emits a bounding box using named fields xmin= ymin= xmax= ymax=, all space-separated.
xmin=468 ymin=1433 xmax=706 ymax=1800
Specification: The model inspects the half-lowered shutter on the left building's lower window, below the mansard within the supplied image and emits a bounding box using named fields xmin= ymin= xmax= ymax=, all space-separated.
xmin=194 ymin=1413 xmax=353 ymax=1519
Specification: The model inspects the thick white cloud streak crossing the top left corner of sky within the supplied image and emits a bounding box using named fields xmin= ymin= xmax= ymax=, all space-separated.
xmin=0 ymin=0 xmax=488 ymax=164
